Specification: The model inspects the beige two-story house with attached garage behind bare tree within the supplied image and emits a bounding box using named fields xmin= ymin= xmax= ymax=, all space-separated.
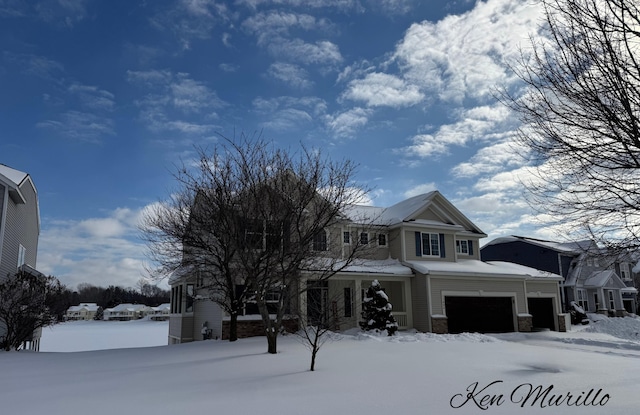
xmin=169 ymin=191 xmax=567 ymax=344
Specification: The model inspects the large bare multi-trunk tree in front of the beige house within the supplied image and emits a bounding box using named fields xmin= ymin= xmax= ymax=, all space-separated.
xmin=142 ymin=136 xmax=366 ymax=353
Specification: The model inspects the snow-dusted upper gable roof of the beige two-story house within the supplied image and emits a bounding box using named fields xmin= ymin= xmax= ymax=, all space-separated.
xmin=344 ymin=190 xmax=487 ymax=236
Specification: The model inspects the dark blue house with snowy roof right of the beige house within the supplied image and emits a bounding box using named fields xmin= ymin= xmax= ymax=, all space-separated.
xmin=481 ymin=236 xmax=637 ymax=316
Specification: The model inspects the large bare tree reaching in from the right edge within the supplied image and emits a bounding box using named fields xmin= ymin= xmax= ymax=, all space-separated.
xmin=502 ymin=0 xmax=640 ymax=254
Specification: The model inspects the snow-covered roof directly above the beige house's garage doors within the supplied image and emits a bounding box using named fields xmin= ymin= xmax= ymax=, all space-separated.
xmin=406 ymin=259 xmax=562 ymax=281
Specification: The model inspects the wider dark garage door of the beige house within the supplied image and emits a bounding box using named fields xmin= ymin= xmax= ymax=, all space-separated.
xmin=444 ymin=297 xmax=514 ymax=333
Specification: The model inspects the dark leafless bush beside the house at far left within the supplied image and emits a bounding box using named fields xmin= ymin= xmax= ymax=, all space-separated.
xmin=0 ymin=271 xmax=65 ymax=351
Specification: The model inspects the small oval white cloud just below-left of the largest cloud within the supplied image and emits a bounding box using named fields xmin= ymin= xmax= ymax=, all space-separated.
xmin=342 ymin=72 xmax=424 ymax=108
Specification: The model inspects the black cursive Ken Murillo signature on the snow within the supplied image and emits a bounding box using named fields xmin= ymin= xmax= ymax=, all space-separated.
xmin=449 ymin=380 xmax=611 ymax=410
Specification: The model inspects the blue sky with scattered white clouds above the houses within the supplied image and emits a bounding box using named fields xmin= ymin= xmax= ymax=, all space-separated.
xmin=0 ymin=0 xmax=553 ymax=287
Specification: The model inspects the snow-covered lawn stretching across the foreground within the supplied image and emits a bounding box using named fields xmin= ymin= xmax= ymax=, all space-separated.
xmin=0 ymin=318 xmax=640 ymax=415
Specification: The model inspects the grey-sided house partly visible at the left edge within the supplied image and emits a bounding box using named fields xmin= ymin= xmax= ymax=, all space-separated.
xmin=0 ymin=164 xmax=42 ymax=350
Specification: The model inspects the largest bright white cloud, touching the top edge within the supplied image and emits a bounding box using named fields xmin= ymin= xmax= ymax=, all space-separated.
xmin=393 ymin=0 xmax=541 ymax=102
